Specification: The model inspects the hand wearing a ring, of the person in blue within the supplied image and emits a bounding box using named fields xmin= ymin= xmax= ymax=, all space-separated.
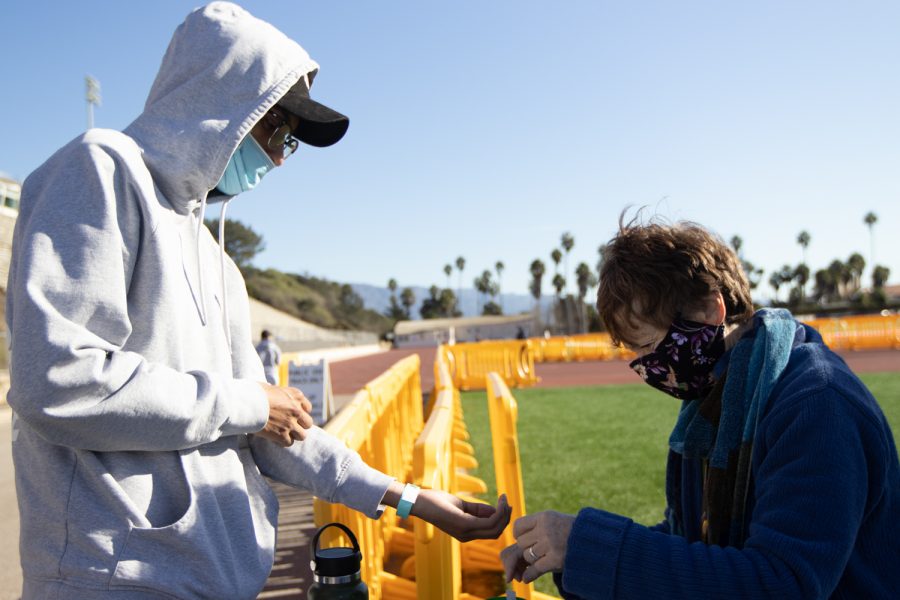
xmin=500 ymin=510 xmax=575 ymax=583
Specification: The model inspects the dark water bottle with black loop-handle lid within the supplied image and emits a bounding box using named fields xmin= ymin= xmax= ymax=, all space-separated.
xmin=308 ymin=523 xmax=369 ymax=600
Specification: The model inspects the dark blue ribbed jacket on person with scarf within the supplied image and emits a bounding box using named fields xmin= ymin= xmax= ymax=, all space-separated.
xmin=555 ymin=327 xmax=900 ymax=600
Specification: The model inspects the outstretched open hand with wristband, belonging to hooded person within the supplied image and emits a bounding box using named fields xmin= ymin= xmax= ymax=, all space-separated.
xmin=412 ymin=489 xmax=512 ymax=542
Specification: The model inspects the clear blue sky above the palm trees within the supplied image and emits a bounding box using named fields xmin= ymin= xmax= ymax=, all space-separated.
xmin=0 ymin=0 xmax=900 ymax=297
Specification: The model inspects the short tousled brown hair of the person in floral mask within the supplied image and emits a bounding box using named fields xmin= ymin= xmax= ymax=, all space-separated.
xmin=597 ymin=211 xmax=753 ymax=344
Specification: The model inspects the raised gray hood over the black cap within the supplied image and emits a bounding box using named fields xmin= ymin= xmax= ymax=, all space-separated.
xmin=125 ymin=2 xmax=319 ymax=214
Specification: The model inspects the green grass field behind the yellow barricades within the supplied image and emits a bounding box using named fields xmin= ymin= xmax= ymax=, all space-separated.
xmin=462 ymin=373 xmax=900 ymax=594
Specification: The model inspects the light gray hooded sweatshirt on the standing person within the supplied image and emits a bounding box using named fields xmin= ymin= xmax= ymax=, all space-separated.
xmin=7 ymin=3 xmax=391 ymax=599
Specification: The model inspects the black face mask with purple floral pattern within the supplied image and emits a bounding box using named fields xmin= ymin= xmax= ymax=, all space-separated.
xmin=629 ymin=318 xmax=725 ymax=400
